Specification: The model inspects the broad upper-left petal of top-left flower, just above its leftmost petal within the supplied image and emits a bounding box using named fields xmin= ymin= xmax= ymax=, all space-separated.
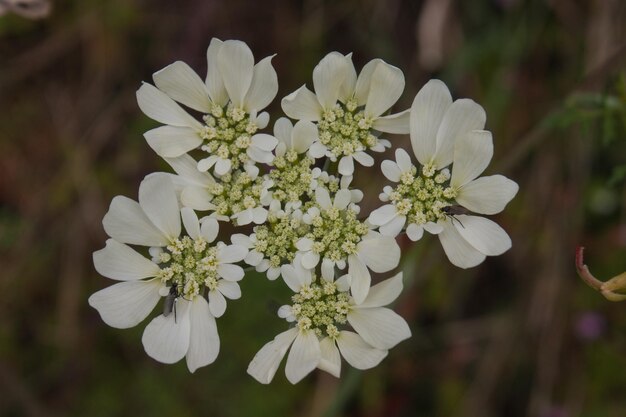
xmin=152 ymin=61 xmax=211 ymax=113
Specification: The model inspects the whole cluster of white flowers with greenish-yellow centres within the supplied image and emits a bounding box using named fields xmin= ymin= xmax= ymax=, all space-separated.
xmin=89 ymin=39 xmax=517 ymax=383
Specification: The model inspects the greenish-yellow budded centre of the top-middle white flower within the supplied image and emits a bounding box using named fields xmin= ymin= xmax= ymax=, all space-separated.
xmin=318 ymin=99 xmax=378 ymax=158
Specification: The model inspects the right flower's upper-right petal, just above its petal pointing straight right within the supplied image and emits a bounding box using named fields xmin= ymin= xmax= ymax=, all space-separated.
xmin=450 ymin=130 xmax=493 ymax=188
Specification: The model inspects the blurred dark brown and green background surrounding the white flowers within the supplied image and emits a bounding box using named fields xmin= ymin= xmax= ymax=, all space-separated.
xmin=0 ymin=0 xmax=626 ymax=417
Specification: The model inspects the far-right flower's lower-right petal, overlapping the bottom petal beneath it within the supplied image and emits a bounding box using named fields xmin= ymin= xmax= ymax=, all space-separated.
xmin=455 ymin=215 xmax=511 ymax=256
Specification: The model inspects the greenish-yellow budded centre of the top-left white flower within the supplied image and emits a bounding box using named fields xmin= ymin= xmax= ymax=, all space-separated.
xmin=200 ymin=103 xmax=258 ymax=169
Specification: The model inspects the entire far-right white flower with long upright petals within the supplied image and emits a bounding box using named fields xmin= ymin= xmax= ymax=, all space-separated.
xmin=369 ymin=80 xmax=518 ymax=268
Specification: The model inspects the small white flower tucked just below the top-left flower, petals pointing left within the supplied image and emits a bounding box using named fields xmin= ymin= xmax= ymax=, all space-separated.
xmin=164 ymin=155 xmax=272 ymax=226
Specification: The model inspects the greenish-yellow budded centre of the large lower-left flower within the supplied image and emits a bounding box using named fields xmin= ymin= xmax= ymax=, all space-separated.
xmin=156 ymin=236 xmax=219 ymax=300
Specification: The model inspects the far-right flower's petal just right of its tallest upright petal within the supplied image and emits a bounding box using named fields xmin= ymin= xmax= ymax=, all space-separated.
xmin=435 ymin=98 xmax=487 ymax=169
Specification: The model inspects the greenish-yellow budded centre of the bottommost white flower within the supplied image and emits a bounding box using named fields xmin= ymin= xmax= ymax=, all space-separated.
xmin=291 ymin=280 xmax=350 ymax=339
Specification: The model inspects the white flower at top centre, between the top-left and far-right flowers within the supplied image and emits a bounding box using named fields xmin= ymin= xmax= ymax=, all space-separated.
xmin=281 ymin=52 xmax=409 ymax=175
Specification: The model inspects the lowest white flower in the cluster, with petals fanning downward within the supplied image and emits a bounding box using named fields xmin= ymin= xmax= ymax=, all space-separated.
xmin=248 ymin=266 xmax=411 ymax=384
